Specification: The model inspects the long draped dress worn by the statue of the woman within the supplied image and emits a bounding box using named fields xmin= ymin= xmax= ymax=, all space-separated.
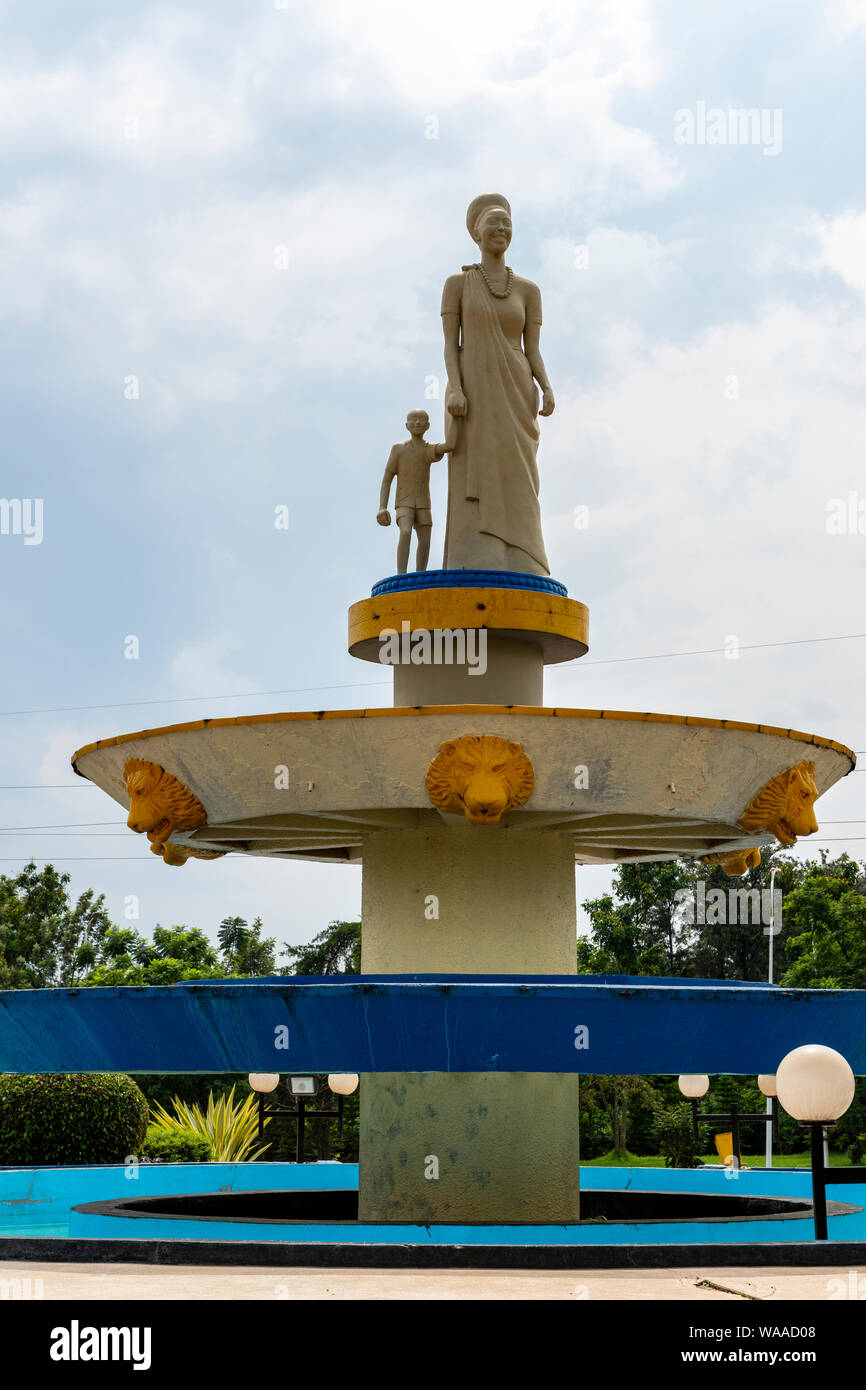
xmin=442 ymin=267 xmax=550 ymax=575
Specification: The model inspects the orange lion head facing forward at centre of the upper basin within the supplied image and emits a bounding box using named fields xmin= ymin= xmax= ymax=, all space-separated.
xmin=425 ymin=734 xmax=535 ymax=826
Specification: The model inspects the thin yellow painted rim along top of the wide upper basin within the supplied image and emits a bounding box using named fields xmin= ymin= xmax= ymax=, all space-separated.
xmin=72 ymin=705 xmax=856 ymax=777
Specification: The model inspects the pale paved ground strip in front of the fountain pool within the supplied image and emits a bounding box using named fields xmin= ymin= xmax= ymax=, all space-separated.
xmin=0 ymin=1261 xmax=866 ymax=1302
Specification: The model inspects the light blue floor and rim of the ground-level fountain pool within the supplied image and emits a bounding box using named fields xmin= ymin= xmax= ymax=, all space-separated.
xmin=0 ymin=1163 xmax=866 ymax=1258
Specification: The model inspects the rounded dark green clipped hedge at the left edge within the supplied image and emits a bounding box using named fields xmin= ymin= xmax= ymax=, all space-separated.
xmin=0 ymin=1072 xmax=149 ymax=1166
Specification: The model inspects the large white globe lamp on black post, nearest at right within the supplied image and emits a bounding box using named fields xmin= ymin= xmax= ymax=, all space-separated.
xmin=776 ymin=1043 xmax=866 ymax=1240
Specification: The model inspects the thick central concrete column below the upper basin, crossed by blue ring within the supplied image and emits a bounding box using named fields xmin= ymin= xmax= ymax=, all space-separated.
xmin=359 ymin=823 xmax=580 ymax=1223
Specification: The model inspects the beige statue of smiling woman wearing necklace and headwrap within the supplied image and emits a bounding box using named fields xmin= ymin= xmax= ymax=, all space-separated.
xmin=442 ymin=193 xmax=555 ymax=575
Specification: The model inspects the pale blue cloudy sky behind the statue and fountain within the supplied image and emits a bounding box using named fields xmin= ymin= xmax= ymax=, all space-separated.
xmin=0 ymin=0 xmax=866 ymax=942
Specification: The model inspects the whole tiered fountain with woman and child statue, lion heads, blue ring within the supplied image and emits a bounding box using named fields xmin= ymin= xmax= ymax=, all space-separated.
xmin=0 ymin=195 xmax=866 ymax=1256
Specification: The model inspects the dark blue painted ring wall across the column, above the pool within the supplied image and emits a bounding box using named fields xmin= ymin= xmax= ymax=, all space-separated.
xmin=0 ymin=976 xmax=866 ymax=1074
